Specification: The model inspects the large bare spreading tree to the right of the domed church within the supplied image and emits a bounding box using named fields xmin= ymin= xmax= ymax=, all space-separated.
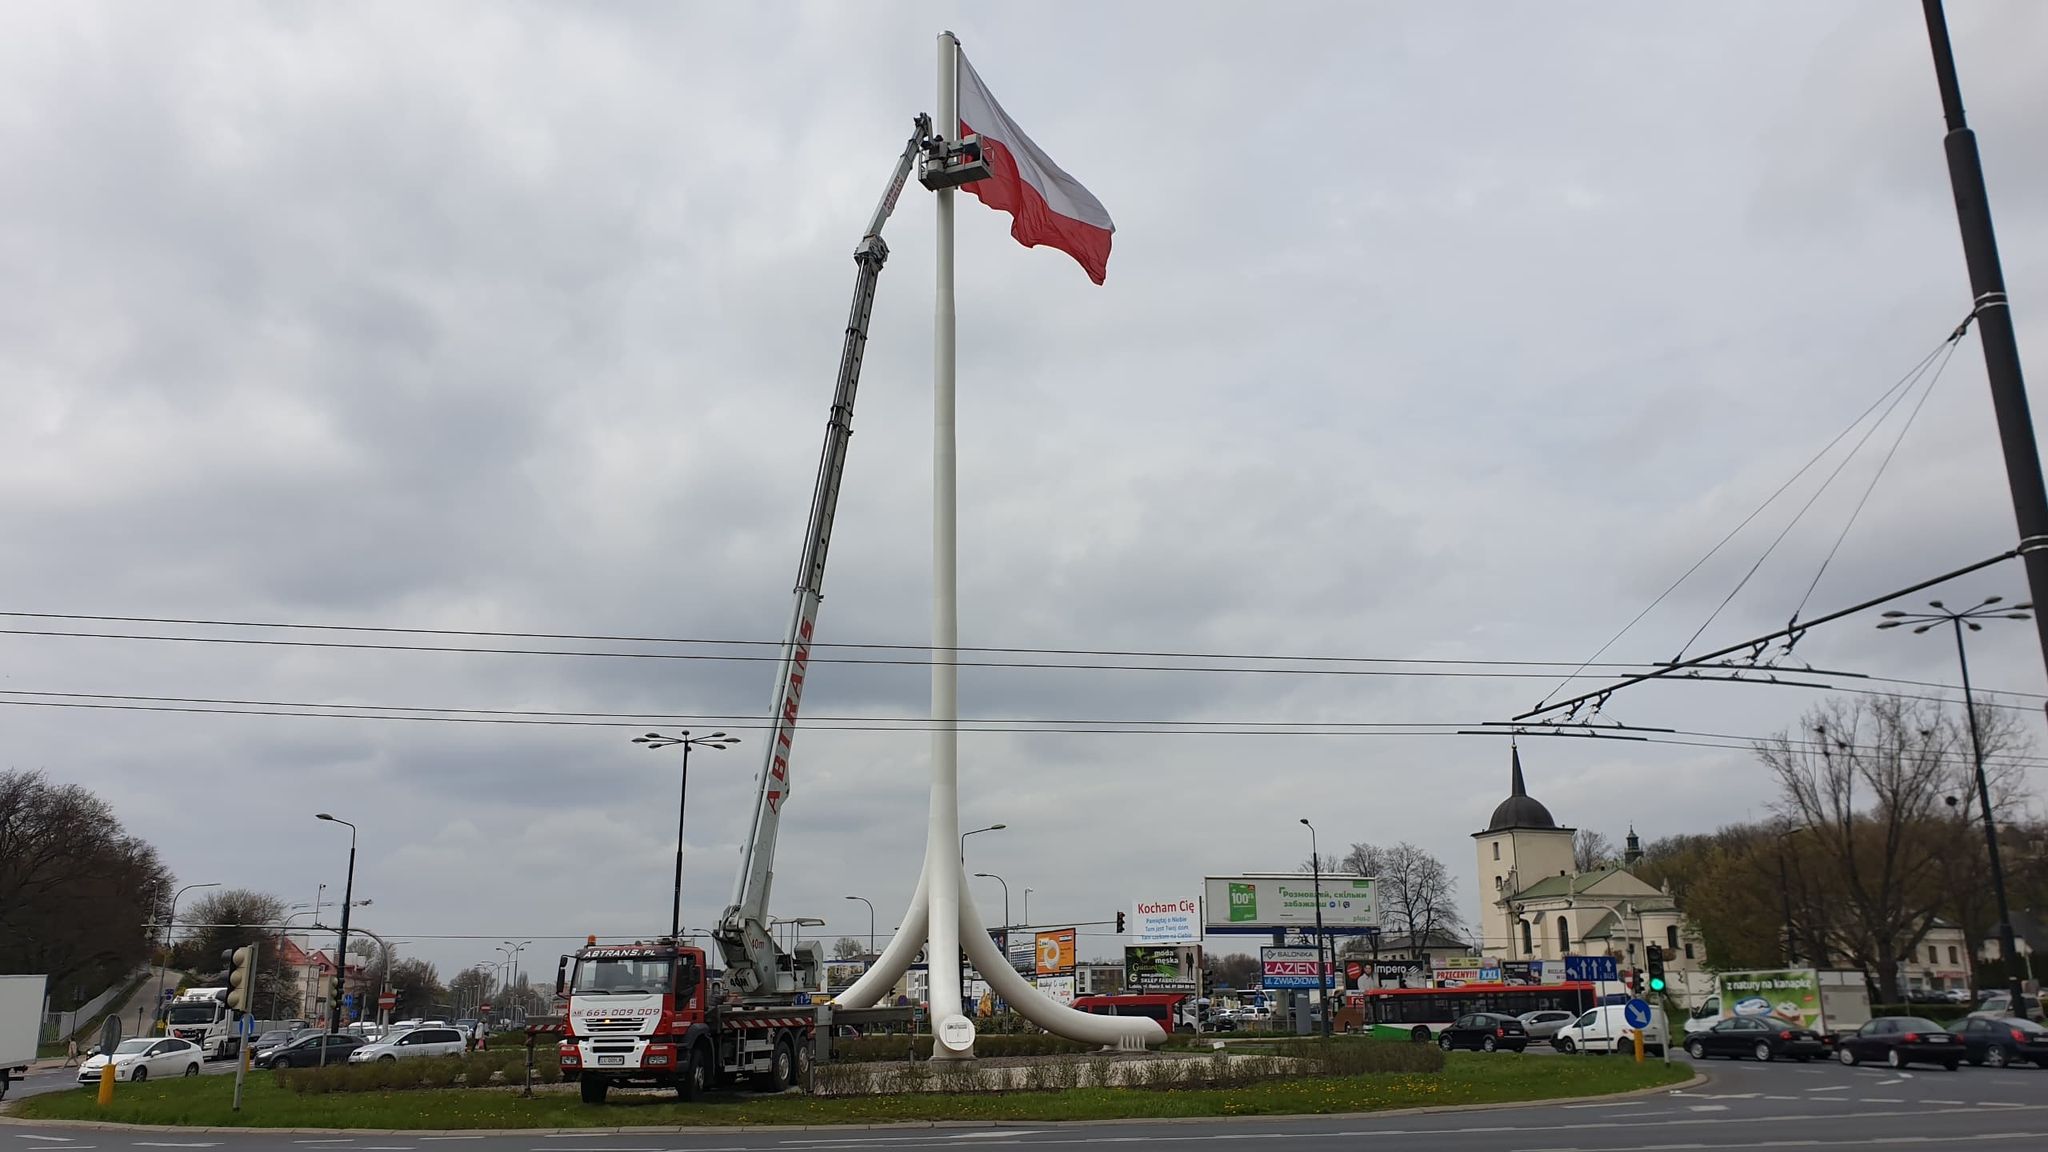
xmin=1757 ymin=697 xmax=2015 ymax=1002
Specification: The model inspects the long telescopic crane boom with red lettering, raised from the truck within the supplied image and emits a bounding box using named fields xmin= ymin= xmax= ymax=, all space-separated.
xmin=713 ymin=115 xmax=932 ymax=996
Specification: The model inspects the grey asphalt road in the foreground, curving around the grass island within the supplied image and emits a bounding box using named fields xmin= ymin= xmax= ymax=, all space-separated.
xmin=0 ymin=1062 xmax=2048 ymax=1152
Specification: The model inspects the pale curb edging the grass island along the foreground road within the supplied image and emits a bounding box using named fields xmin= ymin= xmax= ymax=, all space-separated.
xmin=0 ymin=1072 xmax=1712 ymax=1136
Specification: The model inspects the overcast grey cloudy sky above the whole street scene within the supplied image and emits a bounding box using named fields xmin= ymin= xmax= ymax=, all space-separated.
xmin=0 ymin=0 xmax=2048 ymax=972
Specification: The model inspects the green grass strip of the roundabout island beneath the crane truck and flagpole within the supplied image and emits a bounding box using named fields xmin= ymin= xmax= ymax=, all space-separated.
xmin=10 ymin=1052 xmax=1692 ymax=1129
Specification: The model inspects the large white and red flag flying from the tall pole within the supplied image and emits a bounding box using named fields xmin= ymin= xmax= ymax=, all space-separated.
xmin=958 ymin=51 xmax=1116 ymax=285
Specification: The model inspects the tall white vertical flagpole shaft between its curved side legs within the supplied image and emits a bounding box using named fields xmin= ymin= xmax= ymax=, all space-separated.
xmin=926 ymin=33 xmax=975 ymax=1060
